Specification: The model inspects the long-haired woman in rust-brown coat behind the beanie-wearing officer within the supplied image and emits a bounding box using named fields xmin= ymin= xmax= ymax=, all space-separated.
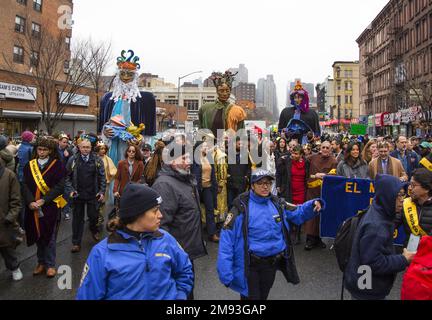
xmin=113 ymin=145 xmax=144 ymax=198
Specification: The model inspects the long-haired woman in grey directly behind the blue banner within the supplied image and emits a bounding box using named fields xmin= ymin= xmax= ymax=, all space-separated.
xmin=336 ymin=142 xmax=369 ymax=179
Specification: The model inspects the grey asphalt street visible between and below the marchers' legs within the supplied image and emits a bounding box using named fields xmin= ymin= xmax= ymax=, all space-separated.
xmin=0 ymin=211 xmax=401 ymax=300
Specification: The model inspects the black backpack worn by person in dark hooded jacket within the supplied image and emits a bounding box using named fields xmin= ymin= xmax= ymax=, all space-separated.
xmin=332 ymin=210 xmax=367 ymax=272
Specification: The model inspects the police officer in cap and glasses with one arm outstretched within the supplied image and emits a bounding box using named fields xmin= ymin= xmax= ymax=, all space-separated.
xmin=217 ymin=170 xmax=325 ymax=300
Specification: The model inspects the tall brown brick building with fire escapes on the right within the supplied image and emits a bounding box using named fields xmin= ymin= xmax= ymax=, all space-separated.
xmin=357 ymin=0 xmax=432 ymax=135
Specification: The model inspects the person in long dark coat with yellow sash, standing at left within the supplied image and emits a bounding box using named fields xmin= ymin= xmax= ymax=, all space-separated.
xmin=23 ymin=138 xmax=66 ymax=278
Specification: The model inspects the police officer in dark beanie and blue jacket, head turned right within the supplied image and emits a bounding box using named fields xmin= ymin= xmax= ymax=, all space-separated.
xmin=77 ymin=184 xmax=194 ymax=300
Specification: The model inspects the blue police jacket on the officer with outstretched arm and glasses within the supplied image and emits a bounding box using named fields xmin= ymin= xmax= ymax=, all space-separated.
xmin=217 ymin=191 xmax=325 ymax=297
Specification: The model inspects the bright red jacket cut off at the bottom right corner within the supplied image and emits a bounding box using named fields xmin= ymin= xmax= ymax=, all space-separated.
xmin=401 ymin=236 xmax=432 ymax=300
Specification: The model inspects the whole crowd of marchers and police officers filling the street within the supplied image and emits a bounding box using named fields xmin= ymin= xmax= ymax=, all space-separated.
xmin=0 ymin=125 xmax=432 ymax=300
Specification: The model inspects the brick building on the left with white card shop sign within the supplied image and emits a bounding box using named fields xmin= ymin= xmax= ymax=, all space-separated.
xmin=0 ymin=0 xmax=96 ymax=136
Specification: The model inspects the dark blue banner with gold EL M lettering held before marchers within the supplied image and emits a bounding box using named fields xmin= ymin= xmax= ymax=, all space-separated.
xmin=321 ymin=176 xmax=406 ymax=245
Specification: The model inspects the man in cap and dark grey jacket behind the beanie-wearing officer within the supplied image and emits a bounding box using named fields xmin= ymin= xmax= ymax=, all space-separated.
xmin=152 ymin=143 xmax=207 ymax=300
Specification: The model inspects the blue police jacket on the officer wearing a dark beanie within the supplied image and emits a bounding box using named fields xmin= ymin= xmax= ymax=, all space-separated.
xmin=76 ymin=230 xmax=194 ymax=300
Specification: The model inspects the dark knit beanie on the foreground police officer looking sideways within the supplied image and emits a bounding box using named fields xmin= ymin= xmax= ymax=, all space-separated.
xmin=119 ymin=183 xmax=162 ymax=219
